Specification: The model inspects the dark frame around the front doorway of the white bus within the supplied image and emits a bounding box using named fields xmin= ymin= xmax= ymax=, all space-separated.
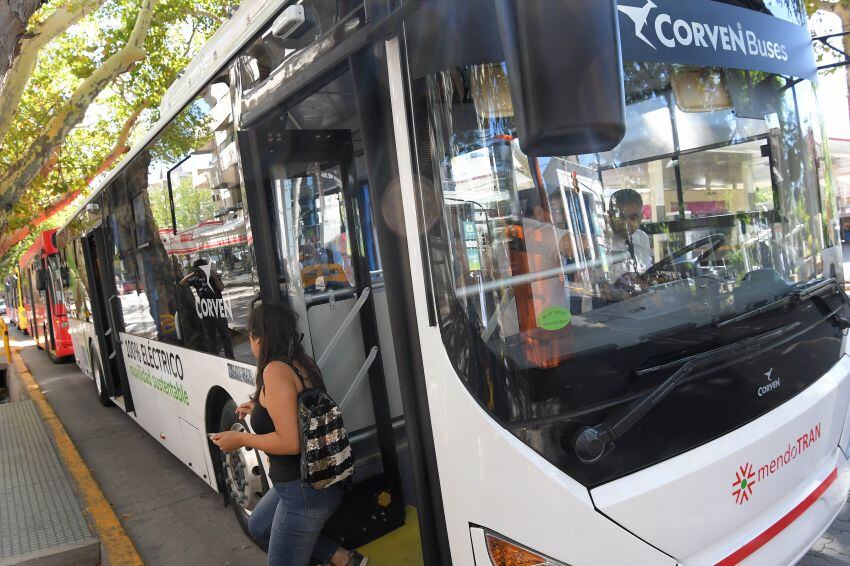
xmin=233 ymin=4 xmax=451 ymax=565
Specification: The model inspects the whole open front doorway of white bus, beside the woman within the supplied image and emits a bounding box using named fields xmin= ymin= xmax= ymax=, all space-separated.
xmin=235 ymin=58 xmax=421 ymax=560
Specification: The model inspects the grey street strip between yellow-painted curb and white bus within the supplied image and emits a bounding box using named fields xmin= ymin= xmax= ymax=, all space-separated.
xmin=11 ymin=329 xmax=266 ymax=566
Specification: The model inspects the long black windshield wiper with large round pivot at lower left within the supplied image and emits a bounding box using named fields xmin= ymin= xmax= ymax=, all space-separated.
xmin=573 ymin=322 xmax=801 ymax=464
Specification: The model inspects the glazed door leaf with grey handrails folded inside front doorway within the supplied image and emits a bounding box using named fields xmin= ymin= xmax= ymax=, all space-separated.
xmin=248 ymin=121 xmax=408 ymax=548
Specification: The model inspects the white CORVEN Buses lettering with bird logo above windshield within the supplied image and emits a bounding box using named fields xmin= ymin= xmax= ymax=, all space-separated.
xmin=617 ymin=0 xmax=788 ymax=61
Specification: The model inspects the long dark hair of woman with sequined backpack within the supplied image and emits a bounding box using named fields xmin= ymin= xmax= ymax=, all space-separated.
xmin=248 ymin=303 xmax=325 ymax=402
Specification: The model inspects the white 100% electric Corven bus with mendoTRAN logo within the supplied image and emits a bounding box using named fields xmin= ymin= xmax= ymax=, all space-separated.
xmin=51 ymin=0 xmax=850 ymax=565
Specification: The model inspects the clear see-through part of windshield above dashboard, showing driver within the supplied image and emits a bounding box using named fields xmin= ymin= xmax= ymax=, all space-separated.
xmin=428 ymin=64 xmax=828 ymax=367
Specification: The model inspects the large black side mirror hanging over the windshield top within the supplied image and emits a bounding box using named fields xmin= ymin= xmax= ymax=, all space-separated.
xmin=496 ymin=0 xmax=626 ymax=157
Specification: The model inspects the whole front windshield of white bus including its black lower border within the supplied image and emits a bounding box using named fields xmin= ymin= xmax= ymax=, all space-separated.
xmin=414 ymin=33 xmax=835 ymax=483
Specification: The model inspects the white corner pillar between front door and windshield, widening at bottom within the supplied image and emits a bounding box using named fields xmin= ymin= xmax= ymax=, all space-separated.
xmin=387 ymin=39 xmax=675 ymax=566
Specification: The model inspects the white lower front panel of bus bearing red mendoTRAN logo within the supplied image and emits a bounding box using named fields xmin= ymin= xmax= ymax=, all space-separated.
xmin=591 ymin=357 xmax=850 ymax=564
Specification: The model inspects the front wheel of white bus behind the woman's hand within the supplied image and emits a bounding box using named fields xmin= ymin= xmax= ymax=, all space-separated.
xmin=219 ymin=399 xmax=268 ymax=537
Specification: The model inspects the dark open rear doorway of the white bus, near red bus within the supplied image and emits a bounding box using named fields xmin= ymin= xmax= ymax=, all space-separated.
xmin=81 ymin=226 xmax=135 ymax=413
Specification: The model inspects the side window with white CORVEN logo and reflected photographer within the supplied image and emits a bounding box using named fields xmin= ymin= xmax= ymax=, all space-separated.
xmin=122 ymin=83 xmax=257 ymax=362
